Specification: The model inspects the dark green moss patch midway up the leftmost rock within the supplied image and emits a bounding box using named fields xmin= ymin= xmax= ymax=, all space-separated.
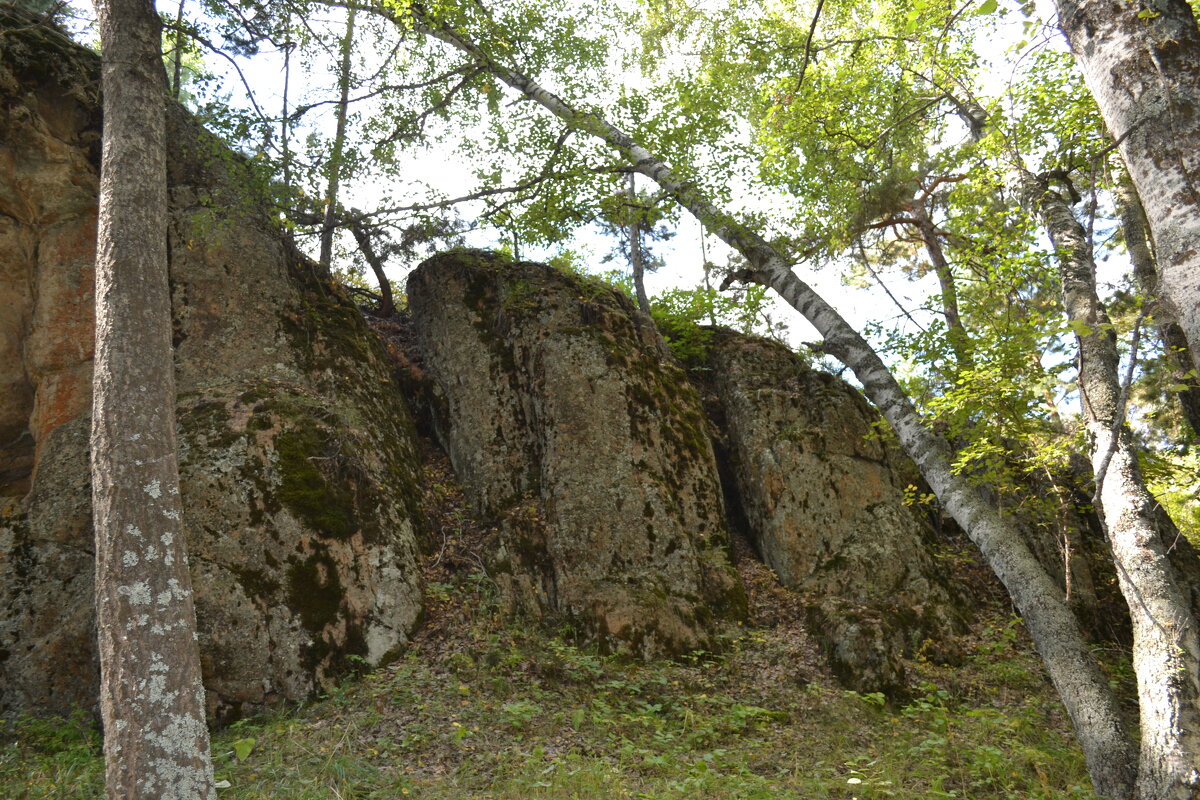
xmin=275 ymin=428 xmax=358 ymax=539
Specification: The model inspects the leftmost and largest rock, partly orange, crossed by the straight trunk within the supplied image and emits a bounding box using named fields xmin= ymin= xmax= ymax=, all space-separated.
xmin=0 ymin=19 xmax=421 ymax=718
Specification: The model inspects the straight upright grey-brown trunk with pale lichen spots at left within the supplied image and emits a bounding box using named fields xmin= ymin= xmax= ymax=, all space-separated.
xmin=91 ymin=0 xmax=216 ymax=800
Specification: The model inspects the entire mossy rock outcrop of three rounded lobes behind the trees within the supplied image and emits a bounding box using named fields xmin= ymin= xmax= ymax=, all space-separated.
xmin=0 ymin=12 xmax=993 ymax=718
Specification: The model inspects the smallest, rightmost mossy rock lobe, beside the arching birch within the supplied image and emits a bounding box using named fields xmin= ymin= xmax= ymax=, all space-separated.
xmin=707 ymin=331 xmax=961 ymax=691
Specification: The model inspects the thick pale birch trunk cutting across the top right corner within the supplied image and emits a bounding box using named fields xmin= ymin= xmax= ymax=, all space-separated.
xmin=1056 ymin=0 xmax=1200 ymax=376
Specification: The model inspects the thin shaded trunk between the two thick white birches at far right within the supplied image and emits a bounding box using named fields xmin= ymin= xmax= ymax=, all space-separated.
xmin=1114 ymin=173 xmax=1200 ymax=439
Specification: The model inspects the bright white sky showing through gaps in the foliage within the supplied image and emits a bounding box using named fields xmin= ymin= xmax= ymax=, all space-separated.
xmin=58 ymin=0 xmax=1128 ymax=391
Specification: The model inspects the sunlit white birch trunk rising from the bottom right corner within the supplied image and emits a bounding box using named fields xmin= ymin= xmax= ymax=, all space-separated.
xmin=1021 ymin=173 xmax=1200 ymax=800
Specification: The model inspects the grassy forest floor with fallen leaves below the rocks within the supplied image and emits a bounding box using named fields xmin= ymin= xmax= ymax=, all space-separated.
xmin=0 ymin=441 xmax=1130 ymax=800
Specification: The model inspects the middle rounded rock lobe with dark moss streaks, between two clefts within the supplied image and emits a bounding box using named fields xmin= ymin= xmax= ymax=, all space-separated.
xmin=408 ymin=252 xmax=744 ymax=657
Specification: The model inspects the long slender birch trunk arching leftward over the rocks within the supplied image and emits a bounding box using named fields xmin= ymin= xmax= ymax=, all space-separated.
xmin=396 ymin=5 xmax=1135 ymax=800
